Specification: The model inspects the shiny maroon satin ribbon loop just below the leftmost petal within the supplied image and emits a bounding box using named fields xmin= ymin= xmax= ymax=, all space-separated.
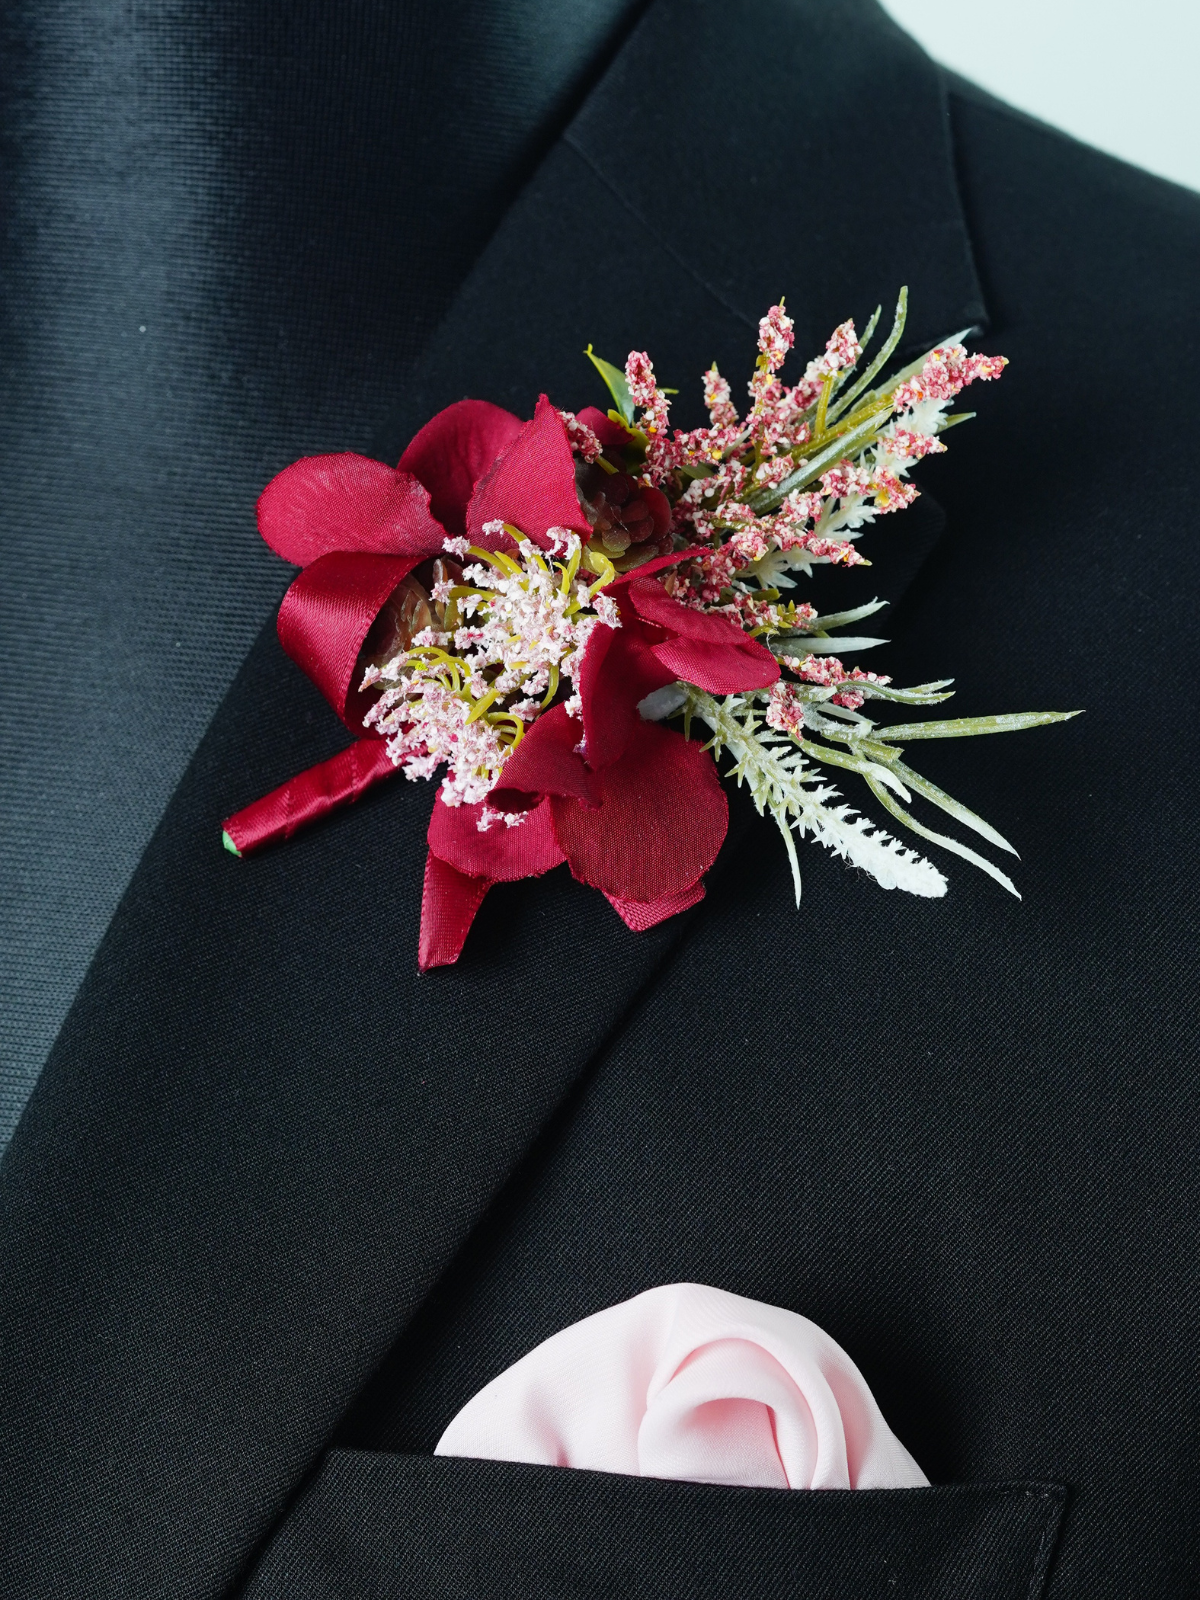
xmin=277 ymin=550 xmax=421 ymax=733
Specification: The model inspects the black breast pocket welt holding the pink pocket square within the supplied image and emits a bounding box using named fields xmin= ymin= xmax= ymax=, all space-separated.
xmin=245 ymin=1451 xmax=1062 ymax=1600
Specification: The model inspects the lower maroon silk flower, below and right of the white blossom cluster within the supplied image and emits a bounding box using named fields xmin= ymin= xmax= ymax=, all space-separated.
xmin=421 ymin=582 xmax=779 ymax=965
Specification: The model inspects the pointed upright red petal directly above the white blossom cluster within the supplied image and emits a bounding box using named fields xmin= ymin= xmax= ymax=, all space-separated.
xmin=467 ymin=395 xmax=592 ymax=549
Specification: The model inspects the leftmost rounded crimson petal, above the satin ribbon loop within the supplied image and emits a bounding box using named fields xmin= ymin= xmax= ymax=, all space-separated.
xmin=258 ymin=451 xmax=445 ymax=566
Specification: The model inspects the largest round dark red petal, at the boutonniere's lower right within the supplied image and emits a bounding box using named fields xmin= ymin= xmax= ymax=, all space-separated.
xmin=549 ymin=720 xmax=730 ymax=901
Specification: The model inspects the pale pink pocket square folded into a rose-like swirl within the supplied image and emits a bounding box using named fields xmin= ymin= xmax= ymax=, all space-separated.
xmin=435 ymin=1283 xmax=928 ymax=1490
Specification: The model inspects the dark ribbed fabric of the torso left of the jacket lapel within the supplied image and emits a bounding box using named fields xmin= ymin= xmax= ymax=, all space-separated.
xmin=0 ymin=0 xmax=640 ymax=1149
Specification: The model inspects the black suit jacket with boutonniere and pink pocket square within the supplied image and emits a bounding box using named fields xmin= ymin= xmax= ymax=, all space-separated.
xmin=0 ymin=0 xmax=1200 ymax=1600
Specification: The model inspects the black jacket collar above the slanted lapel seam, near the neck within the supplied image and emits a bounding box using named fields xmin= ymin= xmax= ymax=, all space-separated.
xmin=566 ymin=0 xmax=984 ymax=355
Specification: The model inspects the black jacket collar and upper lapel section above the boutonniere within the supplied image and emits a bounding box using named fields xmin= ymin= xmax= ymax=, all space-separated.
xmin=381 ymin=0 xmax=987 ymax=454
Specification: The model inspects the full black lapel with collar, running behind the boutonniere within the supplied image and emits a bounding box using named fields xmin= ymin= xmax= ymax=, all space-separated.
xmin=0 ymin=0 xmax=982 ymax=1595
